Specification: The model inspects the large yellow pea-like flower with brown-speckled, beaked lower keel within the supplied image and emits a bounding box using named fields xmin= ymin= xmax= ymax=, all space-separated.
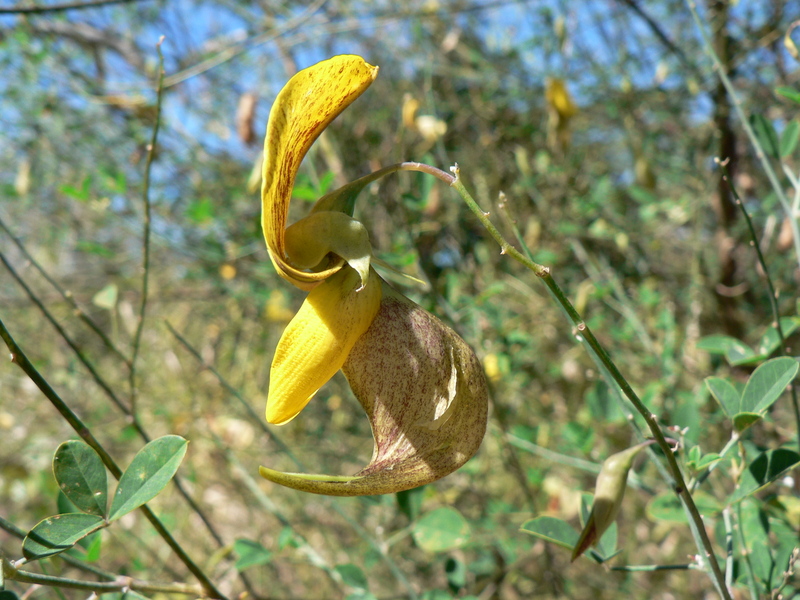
xmin=260 ymin=56 xmax=488 ymax=496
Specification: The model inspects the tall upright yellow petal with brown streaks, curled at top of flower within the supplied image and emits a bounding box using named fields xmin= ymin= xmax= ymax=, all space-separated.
xmin=261 ymin=55 xmax=378 ymax=289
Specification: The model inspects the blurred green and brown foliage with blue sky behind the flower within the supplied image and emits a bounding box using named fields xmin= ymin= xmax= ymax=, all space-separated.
xmin=0 ymin=0 xmax=800 ymax=599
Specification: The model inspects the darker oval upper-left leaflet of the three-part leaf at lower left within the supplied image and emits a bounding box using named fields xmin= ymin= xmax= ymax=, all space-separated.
xmin=53 ymin=440 xmax=108 ymax=517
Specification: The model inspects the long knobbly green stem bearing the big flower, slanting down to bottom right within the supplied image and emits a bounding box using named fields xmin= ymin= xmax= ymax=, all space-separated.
xmin=446 ymin=165 xmax=731 ymax=600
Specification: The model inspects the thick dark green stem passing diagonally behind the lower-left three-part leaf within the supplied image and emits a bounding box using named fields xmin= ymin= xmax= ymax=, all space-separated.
xmin=0 ymin=320 xmax=225 ymax=599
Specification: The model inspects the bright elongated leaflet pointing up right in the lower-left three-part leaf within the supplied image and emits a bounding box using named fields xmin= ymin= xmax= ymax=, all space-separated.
xmin=108 ymin=435 xmax=188 ymax=521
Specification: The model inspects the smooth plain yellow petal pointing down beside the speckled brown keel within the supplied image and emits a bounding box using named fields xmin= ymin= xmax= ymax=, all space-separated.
xmin=267 ymin=268 xmax=381 ymax=425
